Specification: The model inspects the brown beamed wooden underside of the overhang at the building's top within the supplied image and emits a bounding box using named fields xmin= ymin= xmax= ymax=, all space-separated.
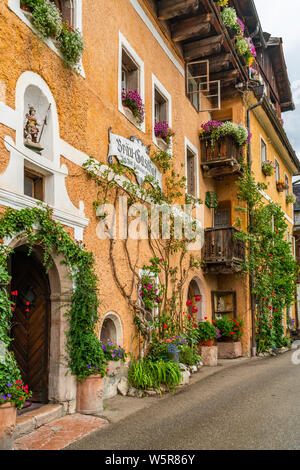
xmin=148 ymin=0 xmax=248 ymax=90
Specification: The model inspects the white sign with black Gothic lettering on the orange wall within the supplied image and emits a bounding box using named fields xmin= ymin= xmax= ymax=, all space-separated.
xmin=108 ymin=129 xmax=162 ymax=189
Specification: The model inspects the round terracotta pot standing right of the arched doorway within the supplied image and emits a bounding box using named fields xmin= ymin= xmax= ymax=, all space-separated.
xmin=76 ymin=375 xmax=104 ymax=415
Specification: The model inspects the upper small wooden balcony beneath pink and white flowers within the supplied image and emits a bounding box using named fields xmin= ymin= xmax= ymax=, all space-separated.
xmin=200 ymin=135 xmax=243 ymax=178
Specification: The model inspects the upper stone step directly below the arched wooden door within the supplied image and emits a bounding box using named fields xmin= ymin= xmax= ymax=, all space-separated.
xmin=14 ymin=404 xmax=63 ymax=439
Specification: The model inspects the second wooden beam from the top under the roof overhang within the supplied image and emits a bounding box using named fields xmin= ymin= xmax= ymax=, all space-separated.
xmin=172 ymin=13 xmax=212 ymax=42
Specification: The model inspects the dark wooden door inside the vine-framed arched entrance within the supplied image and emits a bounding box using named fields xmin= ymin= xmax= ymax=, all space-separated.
xmin=11 ymin=252 xmax=50 ymax=403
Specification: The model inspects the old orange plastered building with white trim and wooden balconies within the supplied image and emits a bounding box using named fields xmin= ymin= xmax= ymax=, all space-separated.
xmin=0 ymin=0 xmax=300 ymax=411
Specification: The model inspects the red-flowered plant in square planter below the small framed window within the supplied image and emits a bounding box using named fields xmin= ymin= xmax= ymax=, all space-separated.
xmin=213 ymin=317 xmax=244 ymax=359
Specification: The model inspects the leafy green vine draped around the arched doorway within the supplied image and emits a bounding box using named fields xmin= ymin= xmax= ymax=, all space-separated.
xmin=0 ymin=205 xmax=106 ymax=381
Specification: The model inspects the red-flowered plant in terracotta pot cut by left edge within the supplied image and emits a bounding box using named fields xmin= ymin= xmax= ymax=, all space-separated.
xmin=0 ymin=352 xmax=32 ymax=450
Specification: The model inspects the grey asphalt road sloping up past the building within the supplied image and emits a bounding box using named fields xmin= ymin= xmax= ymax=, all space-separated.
xmin=67 ymin=352 xmax=300 ymax=450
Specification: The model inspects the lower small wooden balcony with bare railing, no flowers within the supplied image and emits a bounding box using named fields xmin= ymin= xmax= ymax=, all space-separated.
xmin=203 ymin=227 xmax=246 ymax=274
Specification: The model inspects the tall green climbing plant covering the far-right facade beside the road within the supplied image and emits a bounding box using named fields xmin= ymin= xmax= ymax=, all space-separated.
xmin=236 ymin=167 xmax=298 ymax=351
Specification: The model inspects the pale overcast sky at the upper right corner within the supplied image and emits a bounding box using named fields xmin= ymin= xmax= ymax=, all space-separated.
xmin=255 ymin=0 xmax=300 ymax=159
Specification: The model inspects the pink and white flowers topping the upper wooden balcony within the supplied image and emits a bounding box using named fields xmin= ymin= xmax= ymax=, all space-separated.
xmin=200 ymin=121 xmax=251 ymax=147
